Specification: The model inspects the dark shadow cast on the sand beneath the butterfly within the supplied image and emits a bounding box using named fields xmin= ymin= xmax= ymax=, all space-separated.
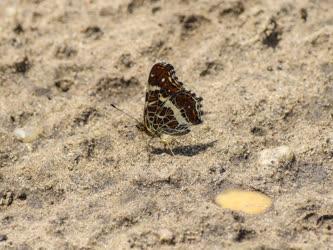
xmin=151 ymin=140 xmax=217 ymax=156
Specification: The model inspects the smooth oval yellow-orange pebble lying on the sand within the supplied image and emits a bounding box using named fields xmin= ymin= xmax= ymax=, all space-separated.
xmin=215 ymin=190 xmax=272 ymax=214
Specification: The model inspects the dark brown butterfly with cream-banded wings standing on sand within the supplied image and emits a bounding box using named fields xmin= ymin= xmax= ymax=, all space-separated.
xmin=112 ymin=62 xmax=203 ymax=154
